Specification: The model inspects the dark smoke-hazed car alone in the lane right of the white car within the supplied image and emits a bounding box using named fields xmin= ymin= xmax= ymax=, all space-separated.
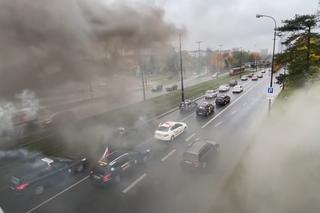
xmin=181 ymin=140 xmax=220 ymax=169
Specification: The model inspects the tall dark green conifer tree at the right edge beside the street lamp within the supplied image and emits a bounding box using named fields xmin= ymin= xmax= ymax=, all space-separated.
xmin=276 ymin=15 xmax=320 ymax=86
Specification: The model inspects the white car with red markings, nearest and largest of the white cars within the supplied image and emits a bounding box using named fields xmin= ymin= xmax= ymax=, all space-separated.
xmin=154 ymin=121 xmax=187 ymax=141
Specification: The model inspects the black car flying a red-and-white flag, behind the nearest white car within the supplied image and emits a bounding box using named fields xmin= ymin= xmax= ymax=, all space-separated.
xmin=90 ymin=150 xmax=150 ymax=186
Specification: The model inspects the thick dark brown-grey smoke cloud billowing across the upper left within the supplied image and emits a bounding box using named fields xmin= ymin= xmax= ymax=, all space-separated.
xmin=0 ymin=0 xmax=176 ymax=94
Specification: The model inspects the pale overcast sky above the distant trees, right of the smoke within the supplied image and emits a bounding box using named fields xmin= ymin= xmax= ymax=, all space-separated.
xmin=161 ymin=0 xmax=318 ymax=51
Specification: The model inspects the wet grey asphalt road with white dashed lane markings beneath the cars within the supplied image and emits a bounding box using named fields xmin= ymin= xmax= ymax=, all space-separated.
xmin=0 ymin=69 xmax=280 ymax=213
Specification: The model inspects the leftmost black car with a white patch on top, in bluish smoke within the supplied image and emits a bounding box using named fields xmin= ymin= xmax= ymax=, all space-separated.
xmin=10 ymin=157 xmax=87 ymax=195
